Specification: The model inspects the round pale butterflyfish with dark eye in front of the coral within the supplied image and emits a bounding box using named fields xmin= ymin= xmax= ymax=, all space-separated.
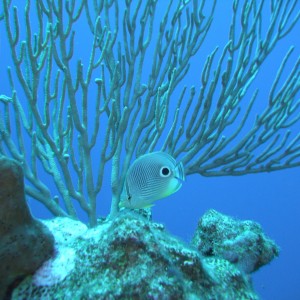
xmin=120 ymin=151 xmax=185 ymax=209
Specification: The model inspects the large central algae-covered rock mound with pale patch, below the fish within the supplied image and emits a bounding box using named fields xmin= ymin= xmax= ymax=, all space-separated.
xmin=12 ymin=211 xmax=278 ymax=300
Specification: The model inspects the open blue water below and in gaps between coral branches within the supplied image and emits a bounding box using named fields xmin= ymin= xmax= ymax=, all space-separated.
xmin=0 ymin=1 xmax=300 ymax=300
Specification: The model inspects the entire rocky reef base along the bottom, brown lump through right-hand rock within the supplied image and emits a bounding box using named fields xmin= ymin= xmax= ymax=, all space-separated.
xmin=0 ymin=156 xmax=278 ymax=300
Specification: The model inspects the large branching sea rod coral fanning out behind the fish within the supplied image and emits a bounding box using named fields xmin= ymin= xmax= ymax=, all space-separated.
xmin=0 ymin=0 xmax=300 ymax=226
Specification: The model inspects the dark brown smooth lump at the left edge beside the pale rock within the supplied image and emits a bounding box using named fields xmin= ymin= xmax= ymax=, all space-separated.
xmin=0 ymin=157 xmax=54 ymax=299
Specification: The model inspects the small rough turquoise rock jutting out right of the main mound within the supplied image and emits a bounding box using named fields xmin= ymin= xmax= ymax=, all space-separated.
xmin=192 ymin=210 xmax=279 ymax=274
